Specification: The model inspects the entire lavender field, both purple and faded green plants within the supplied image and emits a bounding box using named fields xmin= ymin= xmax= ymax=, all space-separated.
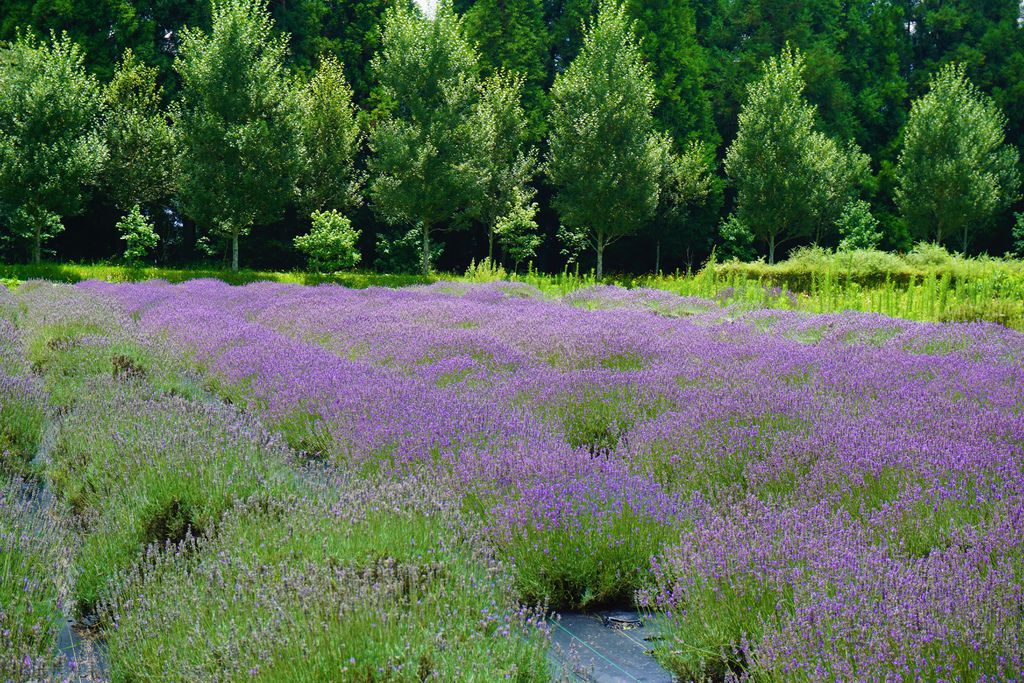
xmin=0 ymin=281 xmax=1024 ymax=681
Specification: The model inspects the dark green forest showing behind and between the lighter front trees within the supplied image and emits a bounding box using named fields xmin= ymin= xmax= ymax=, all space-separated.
xmin=0 ymin=0 xmax=1024 ymax=272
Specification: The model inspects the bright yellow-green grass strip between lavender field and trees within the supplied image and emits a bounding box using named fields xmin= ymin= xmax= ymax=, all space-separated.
xmin=0 ymin=245 xmax=1024 ymax=330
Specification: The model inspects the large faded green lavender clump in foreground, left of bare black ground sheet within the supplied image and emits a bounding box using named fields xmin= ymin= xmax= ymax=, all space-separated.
xmin=104 ymin=489 xmax=549 ymax=683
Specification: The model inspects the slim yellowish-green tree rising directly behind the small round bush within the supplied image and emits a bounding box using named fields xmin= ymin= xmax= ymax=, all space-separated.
xmin=299 ymin=55 xmax=361 ymax=212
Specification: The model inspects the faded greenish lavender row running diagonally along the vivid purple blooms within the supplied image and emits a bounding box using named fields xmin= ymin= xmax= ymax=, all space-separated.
xmin=12 ymin=284 xmax=548 ymax=681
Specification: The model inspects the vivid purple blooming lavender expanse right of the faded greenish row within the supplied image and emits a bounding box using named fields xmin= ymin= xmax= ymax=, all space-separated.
xmin=77 ymin=282 xmax=1024 ymax=680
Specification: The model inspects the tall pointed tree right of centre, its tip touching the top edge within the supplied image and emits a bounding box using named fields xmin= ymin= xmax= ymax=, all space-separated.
xmin=547 ymin=0 xmax=669 ymax=278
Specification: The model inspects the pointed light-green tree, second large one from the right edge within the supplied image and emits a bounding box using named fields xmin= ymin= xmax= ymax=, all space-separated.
xmin=725 ymin=46 xmax=867 ymax=263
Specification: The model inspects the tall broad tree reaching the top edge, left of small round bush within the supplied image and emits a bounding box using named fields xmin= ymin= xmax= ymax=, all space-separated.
xmin=173 ymin=0 xmax=300 ymax=270
